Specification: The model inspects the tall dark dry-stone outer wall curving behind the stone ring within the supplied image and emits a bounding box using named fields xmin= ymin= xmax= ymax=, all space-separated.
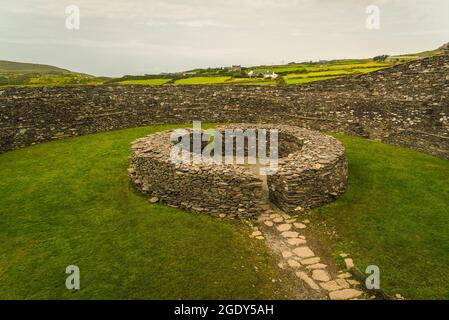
xmin=0 ymin=54 xmax=449 ymax=159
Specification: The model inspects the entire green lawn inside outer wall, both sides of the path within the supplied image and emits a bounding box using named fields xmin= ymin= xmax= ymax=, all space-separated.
xmin=0 ymin=126 xmax=449 ymax=299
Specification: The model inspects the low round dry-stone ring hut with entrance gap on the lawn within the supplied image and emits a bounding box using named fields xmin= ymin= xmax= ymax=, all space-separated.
xmin=128 ymin=124 xmax=348 ymax=218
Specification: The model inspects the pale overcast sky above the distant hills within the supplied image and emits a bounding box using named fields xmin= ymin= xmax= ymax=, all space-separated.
xmin=0 ymin=0 xmax=449 ymax=76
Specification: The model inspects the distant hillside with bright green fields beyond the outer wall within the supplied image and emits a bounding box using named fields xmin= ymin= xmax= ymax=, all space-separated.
xmin=0 ymin=44 xmax=448 ymax=86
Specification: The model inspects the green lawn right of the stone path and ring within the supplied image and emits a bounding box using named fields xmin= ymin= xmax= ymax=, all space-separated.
xmin=314 ymin=135 xmax=449 ymax=299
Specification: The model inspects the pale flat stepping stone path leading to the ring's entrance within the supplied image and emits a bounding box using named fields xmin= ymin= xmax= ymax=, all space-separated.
xmin=251 ymin=205 xmax=367 ymax=300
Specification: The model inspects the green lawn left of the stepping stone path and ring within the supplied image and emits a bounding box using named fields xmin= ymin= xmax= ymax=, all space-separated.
xmin=0 ymin=126 xmax=279 ymax=299
